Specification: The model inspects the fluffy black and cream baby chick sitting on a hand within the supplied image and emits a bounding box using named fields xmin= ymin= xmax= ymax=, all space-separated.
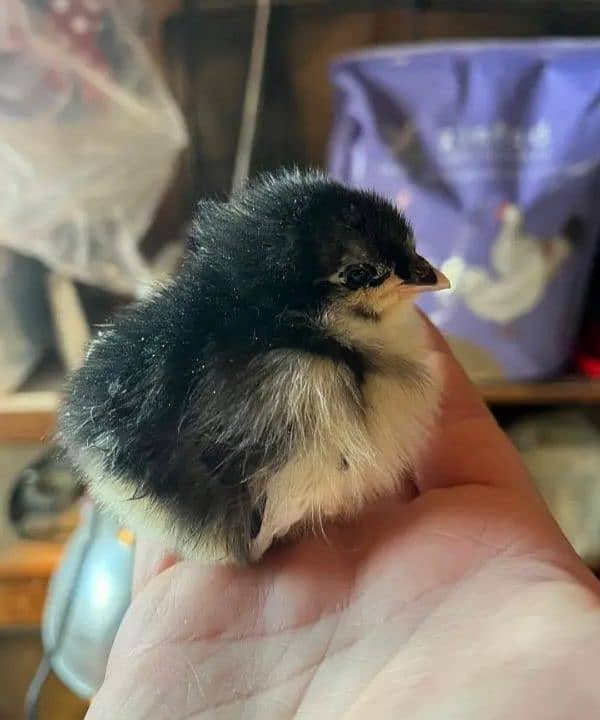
xmin=60 ymin=171 xmax=448 ymax=563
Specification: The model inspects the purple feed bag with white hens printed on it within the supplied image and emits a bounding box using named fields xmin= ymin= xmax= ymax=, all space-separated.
xmin=329 ymin=40 xmax=600 ymax=380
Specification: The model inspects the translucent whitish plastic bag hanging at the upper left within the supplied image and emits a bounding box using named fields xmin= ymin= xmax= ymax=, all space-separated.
xmin=0 ymin=0 xmax=186 ymax=293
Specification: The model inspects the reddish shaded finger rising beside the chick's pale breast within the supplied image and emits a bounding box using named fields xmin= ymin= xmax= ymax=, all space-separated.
xmin=416 ymin=320 xmax=533 ymax=493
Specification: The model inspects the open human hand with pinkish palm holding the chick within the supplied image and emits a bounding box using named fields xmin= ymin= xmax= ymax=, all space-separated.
xmin=87 ymin=330 xmax=600 ymax=720
